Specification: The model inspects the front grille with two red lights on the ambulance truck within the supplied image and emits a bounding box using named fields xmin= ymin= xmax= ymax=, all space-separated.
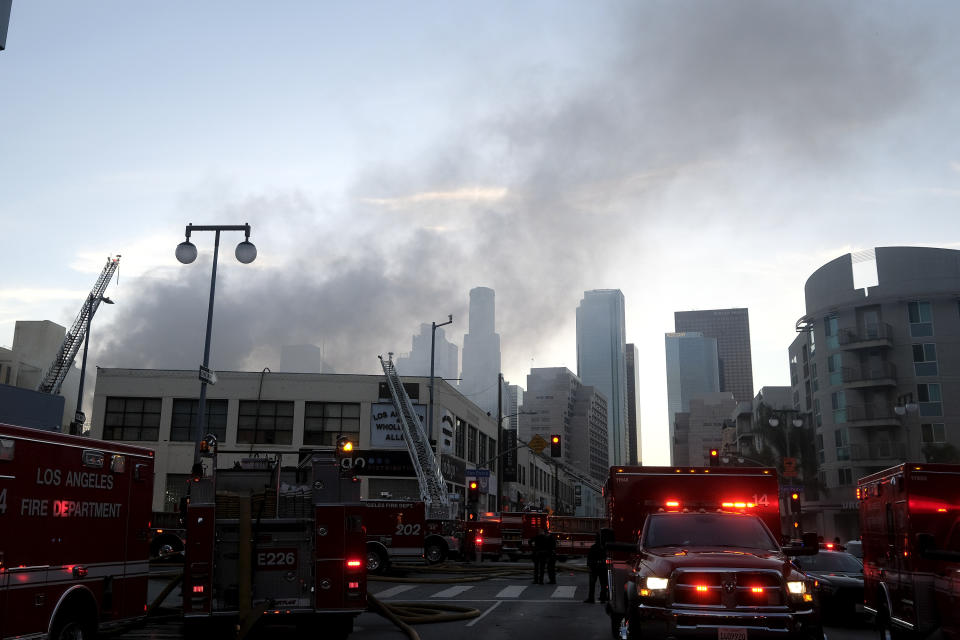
xmin=672 ymin=571 xmax=786 ymax=609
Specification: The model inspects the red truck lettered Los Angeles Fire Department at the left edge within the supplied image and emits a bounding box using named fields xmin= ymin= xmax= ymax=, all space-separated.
xmin=0 ymin=424 xmax=154 ymax=640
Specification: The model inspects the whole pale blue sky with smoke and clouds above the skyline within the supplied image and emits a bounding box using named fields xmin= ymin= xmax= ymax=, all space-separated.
xmin=0 ymin=0 xmax=960 ymax=464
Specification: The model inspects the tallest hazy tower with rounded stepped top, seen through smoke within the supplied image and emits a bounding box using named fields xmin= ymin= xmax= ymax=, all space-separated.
xmin=460 ymin=287 xmax=501 ymax=416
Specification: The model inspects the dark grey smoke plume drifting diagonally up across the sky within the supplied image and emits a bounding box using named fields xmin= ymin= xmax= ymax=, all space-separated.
xmin=92 ymin=0 xmax=936 ymax=373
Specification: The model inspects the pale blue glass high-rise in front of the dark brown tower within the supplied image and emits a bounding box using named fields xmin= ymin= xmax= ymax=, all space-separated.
xmin=664 ymin=331 xmax=720 ymax=464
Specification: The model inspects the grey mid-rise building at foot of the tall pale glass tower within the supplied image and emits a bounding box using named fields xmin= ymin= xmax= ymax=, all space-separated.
xmin=520 ymin=367 xmax=610 ymax=483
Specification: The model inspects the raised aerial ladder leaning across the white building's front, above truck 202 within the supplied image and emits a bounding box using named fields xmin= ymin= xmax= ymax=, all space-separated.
xmin=377 ymin=353 xmax=455 ymax=520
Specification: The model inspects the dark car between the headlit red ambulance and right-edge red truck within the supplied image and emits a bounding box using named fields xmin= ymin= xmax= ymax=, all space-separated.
xmin=793 ymin=550 xmax=863 ymax=619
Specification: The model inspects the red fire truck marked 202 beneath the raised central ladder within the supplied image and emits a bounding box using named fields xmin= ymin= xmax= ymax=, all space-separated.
xmin=363 ymin=500 xmax=460 ymax=573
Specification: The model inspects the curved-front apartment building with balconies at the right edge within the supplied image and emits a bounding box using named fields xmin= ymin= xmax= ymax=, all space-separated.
xmin=789 ymin=247 xmax=960 ymax=539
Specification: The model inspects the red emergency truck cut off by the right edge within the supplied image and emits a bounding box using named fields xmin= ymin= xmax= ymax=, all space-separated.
xmin=857 ymin=462 xmax=960 ymax=638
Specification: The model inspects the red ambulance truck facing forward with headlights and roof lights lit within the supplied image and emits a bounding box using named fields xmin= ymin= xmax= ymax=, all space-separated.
xmin=604 ymin=467 xmax=823 ymax=640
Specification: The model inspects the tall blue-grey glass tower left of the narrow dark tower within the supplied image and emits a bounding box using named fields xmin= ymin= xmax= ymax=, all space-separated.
xmin=577 ymin=289 xmax=630 ymax=465
